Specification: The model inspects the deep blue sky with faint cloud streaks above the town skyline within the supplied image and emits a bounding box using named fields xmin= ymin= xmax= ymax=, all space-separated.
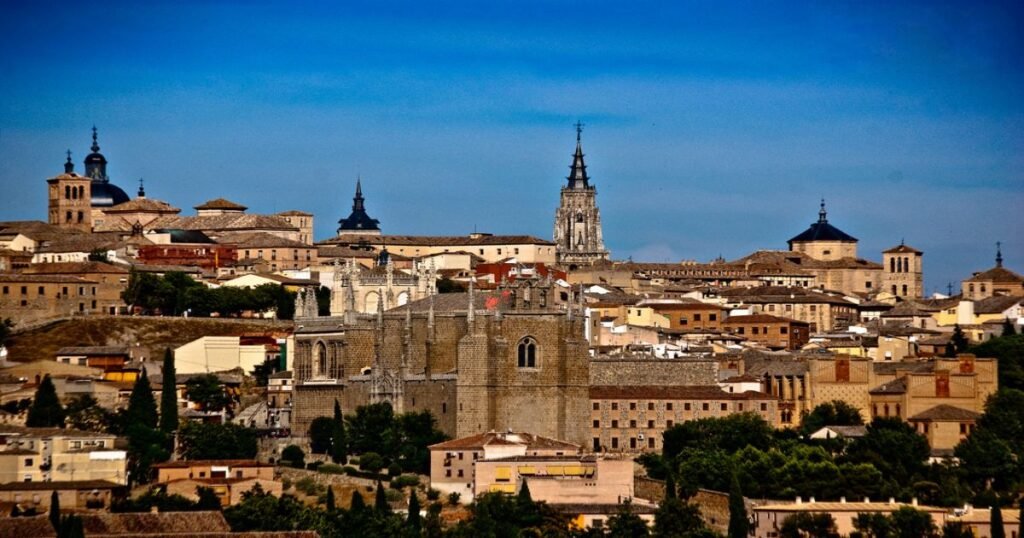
xmin=0 ymin=1 xmax=1024 ymax=292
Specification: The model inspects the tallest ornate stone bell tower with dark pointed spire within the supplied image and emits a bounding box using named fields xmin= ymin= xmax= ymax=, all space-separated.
xmin=554 ymin=122 xmax=608 ymax=270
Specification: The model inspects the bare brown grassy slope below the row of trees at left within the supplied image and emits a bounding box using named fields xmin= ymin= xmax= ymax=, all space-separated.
xmin=7 ymin=317 xmax=293 ymax=362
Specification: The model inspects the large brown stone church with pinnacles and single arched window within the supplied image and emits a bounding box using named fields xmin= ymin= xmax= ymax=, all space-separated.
xmin=292 ymin=279 xmax=590 ymax=445
